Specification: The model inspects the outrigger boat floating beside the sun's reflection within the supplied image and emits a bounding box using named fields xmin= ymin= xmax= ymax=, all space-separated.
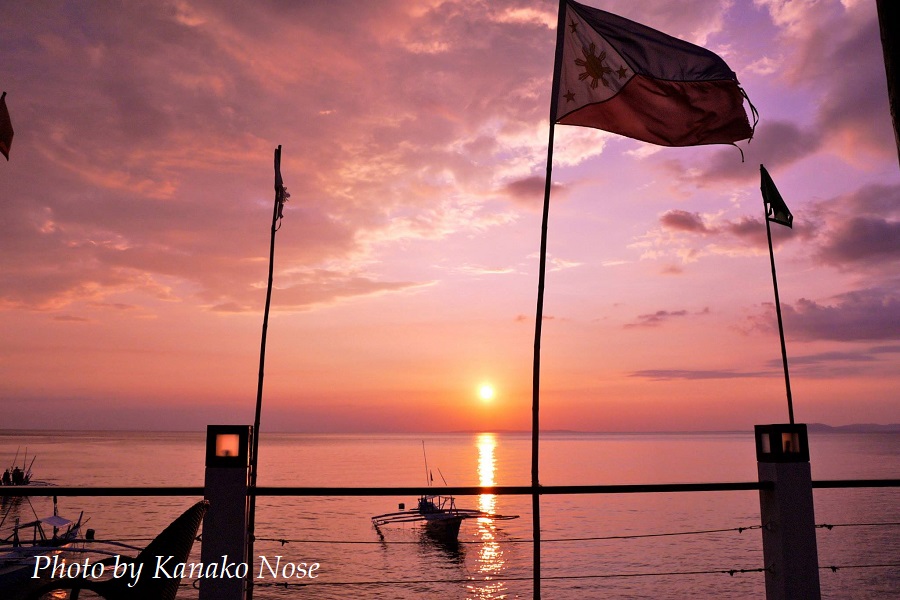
xmin=372 ymin=441 xmax=519 ymax=542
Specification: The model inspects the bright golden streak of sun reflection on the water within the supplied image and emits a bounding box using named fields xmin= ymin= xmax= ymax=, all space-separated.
xmin=469 ymin=433 xmax=506 ymax=600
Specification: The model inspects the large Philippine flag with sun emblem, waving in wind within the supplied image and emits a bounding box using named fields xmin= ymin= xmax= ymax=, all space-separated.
xmin=552 ymin=0 xmax=756 ymax=146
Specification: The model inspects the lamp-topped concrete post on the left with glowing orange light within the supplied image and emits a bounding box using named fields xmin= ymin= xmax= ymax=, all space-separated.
xmin=199 ymin=425 xmax=253 ymax=600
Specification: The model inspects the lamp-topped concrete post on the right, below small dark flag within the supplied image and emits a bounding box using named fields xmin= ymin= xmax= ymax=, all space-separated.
xmin=755 ymin=424 xmax=821 ymax=600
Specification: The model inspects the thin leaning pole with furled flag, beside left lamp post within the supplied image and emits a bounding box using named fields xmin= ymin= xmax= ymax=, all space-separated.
xmin=246 ymin=144 xmax=289 ymax=600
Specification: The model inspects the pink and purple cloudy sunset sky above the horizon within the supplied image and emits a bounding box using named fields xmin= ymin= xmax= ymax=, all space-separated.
xmin=0 ymin=0 xmax=900 ymax=432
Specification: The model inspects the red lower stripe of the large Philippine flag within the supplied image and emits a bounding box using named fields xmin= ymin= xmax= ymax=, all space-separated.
xmin=557 ymin=75 xmax=752 ymax=146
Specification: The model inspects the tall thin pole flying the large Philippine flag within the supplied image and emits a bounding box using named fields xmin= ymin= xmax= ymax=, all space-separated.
xmin=531 ymin=0 xmax=566 ymax=600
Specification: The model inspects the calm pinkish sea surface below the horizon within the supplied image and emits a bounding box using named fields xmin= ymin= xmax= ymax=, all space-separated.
xmin=0 ymin=432 xmax=900 ymax=600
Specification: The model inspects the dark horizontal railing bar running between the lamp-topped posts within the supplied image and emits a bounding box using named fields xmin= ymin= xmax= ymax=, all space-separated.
xmin=0 ymin=479 xmax=900 ymax=496
